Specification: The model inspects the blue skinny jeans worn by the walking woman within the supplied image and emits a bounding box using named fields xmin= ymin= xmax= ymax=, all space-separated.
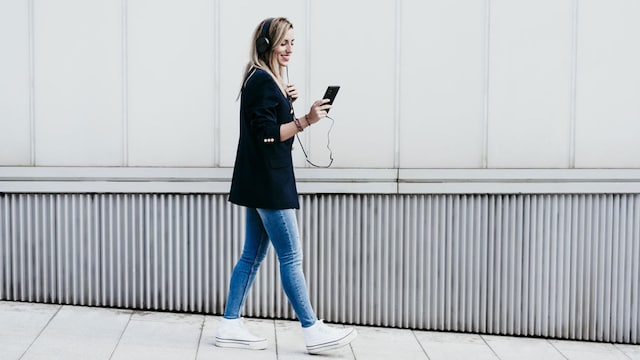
xmin=224 ymin=208 xmax=317 ymax=328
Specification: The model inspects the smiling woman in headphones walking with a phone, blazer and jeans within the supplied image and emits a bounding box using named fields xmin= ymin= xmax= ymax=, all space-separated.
xmin=216 ymin=18 xmax=356 ymax=354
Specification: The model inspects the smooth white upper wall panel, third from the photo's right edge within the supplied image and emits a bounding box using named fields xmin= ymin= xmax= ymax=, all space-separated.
xmin=398 ymin=0 xmax=487 ymax=168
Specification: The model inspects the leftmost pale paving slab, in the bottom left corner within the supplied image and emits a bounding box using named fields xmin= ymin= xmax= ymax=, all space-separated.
xmin=0 ymin=301 xmax=62 ymax=359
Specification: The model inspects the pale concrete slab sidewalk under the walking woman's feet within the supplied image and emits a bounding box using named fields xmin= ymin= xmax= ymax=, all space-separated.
xmin=0 ymin=301 xmax=640 ymax=360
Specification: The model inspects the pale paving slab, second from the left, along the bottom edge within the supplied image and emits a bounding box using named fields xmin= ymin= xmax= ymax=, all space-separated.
xmin=22 ymin=306 xmax=131 ymax=360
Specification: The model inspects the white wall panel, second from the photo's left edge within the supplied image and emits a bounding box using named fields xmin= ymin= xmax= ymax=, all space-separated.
xmin=32 ymin=0 xmax=124 ymax=166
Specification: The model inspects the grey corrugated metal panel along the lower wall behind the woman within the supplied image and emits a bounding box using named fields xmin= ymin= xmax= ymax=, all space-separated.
xmin=0 ymin=194 xmax=640 ymax=344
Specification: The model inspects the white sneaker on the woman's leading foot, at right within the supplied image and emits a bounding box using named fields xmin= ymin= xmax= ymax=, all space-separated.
xmin=302 ymin=320 xmax=358 ymax=354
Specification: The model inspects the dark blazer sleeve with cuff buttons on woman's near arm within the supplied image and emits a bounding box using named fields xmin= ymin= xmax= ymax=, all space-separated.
xmin=243 ymin=71 xmax=281 ymax=145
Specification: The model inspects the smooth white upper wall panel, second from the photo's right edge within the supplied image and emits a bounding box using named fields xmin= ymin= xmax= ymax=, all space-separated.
xmin=487 ymin=0 xmax=574 ymax=168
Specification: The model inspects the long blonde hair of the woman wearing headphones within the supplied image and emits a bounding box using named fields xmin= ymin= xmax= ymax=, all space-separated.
xmin=240 ymin=17 xmax=293 ymax=93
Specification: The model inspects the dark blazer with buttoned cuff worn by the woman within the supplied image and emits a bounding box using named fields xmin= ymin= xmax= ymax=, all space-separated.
xmin=229 ymin=69 xmax=300 ymax=209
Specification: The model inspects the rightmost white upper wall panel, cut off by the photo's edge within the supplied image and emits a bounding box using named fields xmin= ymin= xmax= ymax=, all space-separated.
xmin=575 ymin=0 xmax=640 ymax=168
